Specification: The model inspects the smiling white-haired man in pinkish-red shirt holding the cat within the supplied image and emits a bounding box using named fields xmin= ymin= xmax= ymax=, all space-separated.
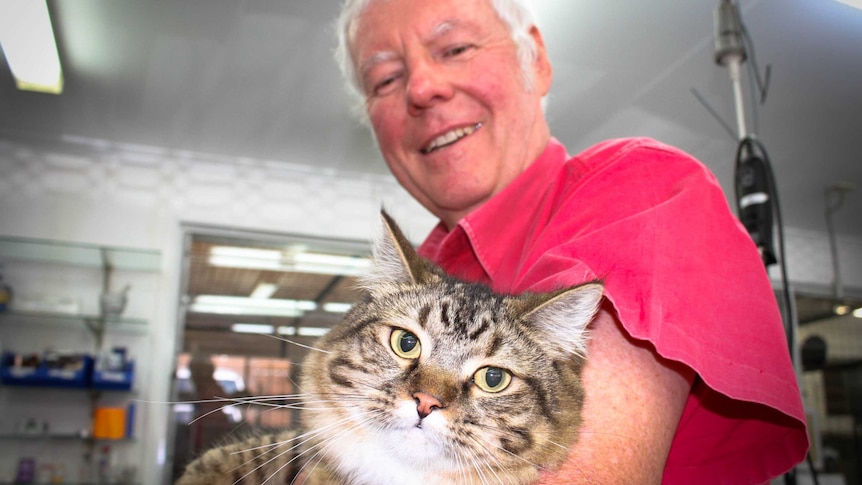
xmin=339 ymin=0 xmax=807 ymax=484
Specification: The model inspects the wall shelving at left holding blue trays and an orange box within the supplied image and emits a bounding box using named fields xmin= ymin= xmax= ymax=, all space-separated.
xmin=0 ymin=236 xmax=161 ymax=484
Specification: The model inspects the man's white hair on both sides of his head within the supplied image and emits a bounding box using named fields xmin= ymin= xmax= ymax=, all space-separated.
xmin=335 ymin=0 xmax=538 ymax=115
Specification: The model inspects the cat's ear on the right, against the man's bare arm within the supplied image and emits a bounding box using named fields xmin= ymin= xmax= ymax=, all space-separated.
xmin=515 ymin=282 xmax=604 ymax=356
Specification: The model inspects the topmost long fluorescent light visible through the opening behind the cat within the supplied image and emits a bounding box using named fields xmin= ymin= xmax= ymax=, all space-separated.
xmin=209 ymin=246 xmax=371 ymax=276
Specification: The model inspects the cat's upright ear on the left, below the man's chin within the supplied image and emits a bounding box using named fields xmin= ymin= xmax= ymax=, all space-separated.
xmin=362 ymin=211 xmax=435 ymax=293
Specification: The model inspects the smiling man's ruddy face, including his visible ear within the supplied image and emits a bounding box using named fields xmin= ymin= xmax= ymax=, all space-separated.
xmin=351 ymin=0 xmax=551 ymax=227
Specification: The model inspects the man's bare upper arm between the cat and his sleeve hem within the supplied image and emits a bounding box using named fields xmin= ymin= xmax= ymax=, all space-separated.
xmin=540 ymin=302 xmax=694 ymax=485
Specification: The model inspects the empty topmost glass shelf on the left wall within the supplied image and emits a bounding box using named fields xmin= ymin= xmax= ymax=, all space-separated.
xmin=0 ymin=236 xmax=162 ymax=272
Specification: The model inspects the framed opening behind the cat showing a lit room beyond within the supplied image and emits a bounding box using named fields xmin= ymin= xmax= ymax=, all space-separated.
xmin=170 ymin=226 xmax=371 ymax=481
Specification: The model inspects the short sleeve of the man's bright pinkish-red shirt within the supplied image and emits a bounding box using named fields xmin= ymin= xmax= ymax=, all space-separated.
xmin=516 ymin=140 xmax=807 ymax=482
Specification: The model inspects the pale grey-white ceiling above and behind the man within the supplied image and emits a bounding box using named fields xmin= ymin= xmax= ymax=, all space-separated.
xmin=0 ymin=0 xmax=862 ymax=237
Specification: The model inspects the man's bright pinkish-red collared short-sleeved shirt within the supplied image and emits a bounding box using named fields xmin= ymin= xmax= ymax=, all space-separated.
xmin=419 ymin=139 xmax=808 ymax=485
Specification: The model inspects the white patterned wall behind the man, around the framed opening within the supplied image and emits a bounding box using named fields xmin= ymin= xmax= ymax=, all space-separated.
xmin=0 ymin=134 xmax=862 ymax=484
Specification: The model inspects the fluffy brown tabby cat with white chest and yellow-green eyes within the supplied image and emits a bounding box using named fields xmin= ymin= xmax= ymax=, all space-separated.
xmin=177 ymin=213 xmax=602 ymax=485
